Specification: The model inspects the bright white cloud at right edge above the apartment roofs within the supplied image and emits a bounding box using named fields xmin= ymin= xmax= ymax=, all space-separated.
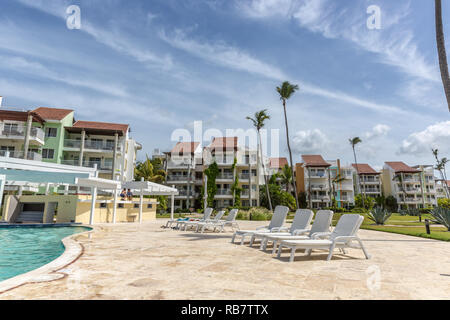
xmin=398 ymin=121 xmax=450 ymax=155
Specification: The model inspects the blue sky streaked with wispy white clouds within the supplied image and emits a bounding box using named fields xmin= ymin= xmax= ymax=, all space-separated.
xmin=0 ymin=0 xmax=450 ymax=167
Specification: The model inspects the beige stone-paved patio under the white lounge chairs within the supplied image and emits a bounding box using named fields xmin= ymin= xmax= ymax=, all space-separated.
xmin=0 ymin=220 xmax=450 ymax=300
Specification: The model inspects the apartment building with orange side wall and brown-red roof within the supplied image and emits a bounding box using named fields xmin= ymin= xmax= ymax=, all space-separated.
xmin=295 ymin=155 xmax=332 ymax=209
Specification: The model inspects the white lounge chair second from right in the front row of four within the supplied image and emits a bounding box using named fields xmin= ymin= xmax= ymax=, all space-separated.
xmin=262 ymin=210 xmax=334 ymax=254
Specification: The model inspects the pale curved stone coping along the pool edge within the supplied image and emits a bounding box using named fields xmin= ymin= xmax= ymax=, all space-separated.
xmin=0 ymin=224 xmax=96 ymax=296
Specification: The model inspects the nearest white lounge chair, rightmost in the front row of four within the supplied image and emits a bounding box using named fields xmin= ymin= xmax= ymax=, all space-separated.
xmin=278 ymin=214 xmax=370 ymax=262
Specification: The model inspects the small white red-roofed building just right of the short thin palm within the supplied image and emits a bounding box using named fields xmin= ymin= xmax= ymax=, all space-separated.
xmin=352 ymin=163 xmax=383 ymax=199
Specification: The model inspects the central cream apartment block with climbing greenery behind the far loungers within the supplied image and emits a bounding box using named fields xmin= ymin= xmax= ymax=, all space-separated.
xmin=165 ymin=137 xmax=264 ymax=209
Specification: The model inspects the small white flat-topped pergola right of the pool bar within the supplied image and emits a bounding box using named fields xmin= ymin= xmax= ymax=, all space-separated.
xmin=122 ymin=181 xmax=179 ymax=222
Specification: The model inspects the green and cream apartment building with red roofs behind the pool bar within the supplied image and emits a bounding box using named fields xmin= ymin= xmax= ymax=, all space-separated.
xmin=0 ymin=103 xmax=142 ymax=181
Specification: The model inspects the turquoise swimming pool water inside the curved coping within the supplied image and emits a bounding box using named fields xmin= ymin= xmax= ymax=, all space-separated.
xmin=0 ymin=226 xmax=89 ymax=281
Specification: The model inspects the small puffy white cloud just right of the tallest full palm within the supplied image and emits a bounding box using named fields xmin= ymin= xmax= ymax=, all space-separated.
xmin=292 ymin=129 xmax=329 ymax=154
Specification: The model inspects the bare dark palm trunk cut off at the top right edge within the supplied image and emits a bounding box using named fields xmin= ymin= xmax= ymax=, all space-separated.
xmin=435 ymin=0 xmax=450 ymax=111
